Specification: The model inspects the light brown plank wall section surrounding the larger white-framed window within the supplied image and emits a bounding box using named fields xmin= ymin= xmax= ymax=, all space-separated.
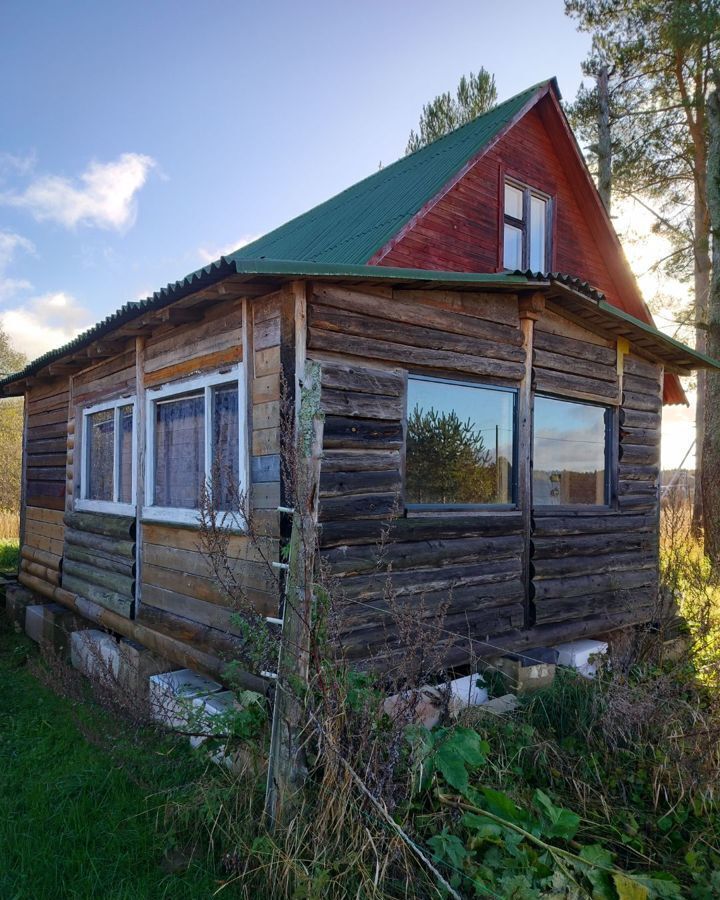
xmin=138 ymin=299 xmax=279 ymax=656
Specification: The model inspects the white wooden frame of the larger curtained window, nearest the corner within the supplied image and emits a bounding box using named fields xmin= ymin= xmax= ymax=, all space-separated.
xmin=142 ymin=364 xmax=249 ymax=525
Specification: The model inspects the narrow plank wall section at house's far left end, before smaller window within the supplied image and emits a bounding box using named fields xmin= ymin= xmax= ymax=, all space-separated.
xmin=19 ymin=375 xmax=72 ymax=588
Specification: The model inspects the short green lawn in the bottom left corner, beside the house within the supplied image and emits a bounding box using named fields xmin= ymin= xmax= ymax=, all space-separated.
xmin=0 ymin=613 xmax=228 ymax=900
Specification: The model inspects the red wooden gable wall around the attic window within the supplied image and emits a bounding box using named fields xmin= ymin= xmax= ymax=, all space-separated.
xmin=369 ymin=86 xmax=686 ymax=403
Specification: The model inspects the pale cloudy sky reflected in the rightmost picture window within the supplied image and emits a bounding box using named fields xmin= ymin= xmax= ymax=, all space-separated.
xmin=533 ymin=397 xmax=605 ymax=472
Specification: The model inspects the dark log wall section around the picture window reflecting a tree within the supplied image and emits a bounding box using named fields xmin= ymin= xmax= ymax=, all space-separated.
xmin=308 ymin=286 xmax=525 ymax=664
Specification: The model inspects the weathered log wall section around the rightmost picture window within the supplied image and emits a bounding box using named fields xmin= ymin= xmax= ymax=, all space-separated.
xmin=530 ymin=310 xmax=662 ymax=630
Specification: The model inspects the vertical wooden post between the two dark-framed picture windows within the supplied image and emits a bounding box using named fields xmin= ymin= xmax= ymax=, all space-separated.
xmin=518 ymin=293 xmax=545 ymax=628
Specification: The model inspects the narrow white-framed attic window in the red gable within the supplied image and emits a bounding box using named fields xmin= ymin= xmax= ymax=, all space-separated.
xmin=503 ymin=180 xmax=551 ymax=272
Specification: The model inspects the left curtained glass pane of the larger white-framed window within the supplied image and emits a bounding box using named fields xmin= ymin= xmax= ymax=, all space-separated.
xmin=153 ymin=393 xmax=205 ymax=509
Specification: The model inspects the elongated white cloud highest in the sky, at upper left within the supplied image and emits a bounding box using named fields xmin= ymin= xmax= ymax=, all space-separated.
xmin=0 ymin=153 xmax=155 ymax=231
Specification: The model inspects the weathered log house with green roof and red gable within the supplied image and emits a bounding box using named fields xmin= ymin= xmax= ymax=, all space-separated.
xmin=0 ymin=81 xmax=718 ymax=673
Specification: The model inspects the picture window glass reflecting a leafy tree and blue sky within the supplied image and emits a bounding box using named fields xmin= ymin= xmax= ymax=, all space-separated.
xmin=405 ymin=378 xmax=515 ymax=504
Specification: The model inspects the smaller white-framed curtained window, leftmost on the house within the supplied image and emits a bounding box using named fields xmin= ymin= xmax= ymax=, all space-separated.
xmin=77 ymin=398 xmax=135 ymax=515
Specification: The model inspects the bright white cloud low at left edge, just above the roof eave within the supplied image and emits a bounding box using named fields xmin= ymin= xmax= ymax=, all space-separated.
xmin=0 ymin=291 xmax=93 ymax=359
